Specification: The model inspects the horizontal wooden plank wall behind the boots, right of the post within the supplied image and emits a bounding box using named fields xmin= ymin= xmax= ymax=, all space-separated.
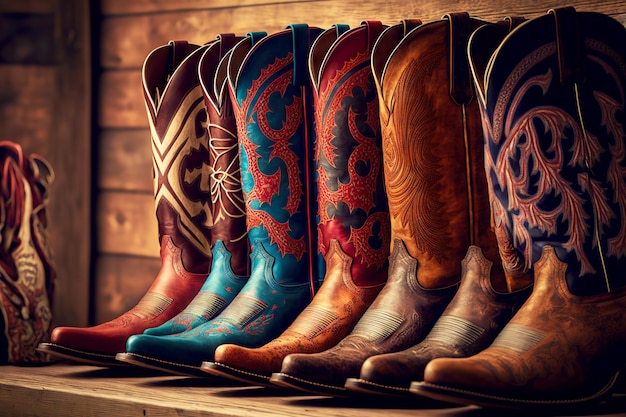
xmin=94 ymin=0 xmax=626 ymax=322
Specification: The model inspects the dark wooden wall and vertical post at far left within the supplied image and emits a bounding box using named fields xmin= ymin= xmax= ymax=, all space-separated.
xmin=0 ymin=0 xmax=92 ymax=325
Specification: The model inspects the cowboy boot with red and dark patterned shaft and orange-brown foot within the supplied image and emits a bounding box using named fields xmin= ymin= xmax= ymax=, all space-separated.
xmin=202 ymin=21 xmax=389 ymax=385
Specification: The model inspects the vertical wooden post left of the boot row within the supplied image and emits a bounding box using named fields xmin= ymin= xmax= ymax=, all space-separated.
xmin=48 ymin=0 xmax=93 ymax=325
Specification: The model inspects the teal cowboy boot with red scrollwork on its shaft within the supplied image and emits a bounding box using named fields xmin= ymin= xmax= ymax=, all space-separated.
xmin=117 ymin=25 xmax=321 ymax=376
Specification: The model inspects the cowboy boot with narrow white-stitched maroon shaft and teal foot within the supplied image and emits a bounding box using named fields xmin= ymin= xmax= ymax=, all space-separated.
xmin=116 ymin=34 xmax=250 ymax=344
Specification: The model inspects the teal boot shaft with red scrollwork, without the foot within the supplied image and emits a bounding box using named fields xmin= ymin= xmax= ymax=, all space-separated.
xmin=228 ymin=25 xmax=323 ymax=286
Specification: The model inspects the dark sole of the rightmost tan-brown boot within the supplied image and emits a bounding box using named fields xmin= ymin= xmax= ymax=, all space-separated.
xmin=409 ymin=374 xmax=618 ymax=410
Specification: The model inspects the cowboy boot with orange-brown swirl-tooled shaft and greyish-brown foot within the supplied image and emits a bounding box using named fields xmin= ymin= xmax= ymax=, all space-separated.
xmin=272 ymin=14 xmax=497 ymax=395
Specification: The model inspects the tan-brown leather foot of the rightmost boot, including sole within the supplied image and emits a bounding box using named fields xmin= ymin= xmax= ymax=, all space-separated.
xmin=411 ymin=246 xmax=626 ymax=408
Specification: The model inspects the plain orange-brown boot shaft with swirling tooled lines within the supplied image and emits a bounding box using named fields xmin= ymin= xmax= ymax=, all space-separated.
xmin=374 ymin=13 xmax=503 ymax=288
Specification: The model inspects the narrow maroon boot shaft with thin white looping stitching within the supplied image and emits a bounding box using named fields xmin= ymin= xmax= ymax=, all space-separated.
xmin=198 ymin=33 xmax=250 ymax=276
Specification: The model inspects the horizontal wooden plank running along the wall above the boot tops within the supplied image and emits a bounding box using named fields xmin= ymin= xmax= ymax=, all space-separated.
xmin=100 ymin=0 xmax=626 ymax=68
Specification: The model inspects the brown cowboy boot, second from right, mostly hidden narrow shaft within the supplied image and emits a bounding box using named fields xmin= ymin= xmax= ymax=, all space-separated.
xmin=346 ymin=14 xmax=532 ymax=396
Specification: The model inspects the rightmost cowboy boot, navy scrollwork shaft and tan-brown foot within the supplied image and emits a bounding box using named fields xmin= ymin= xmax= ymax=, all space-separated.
xmin=411 ymin=8 xmax=626 ymax=409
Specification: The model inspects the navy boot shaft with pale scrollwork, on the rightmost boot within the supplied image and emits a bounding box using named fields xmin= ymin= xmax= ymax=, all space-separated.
xmin=470 ymin=8 xmax=626 ymax=295
